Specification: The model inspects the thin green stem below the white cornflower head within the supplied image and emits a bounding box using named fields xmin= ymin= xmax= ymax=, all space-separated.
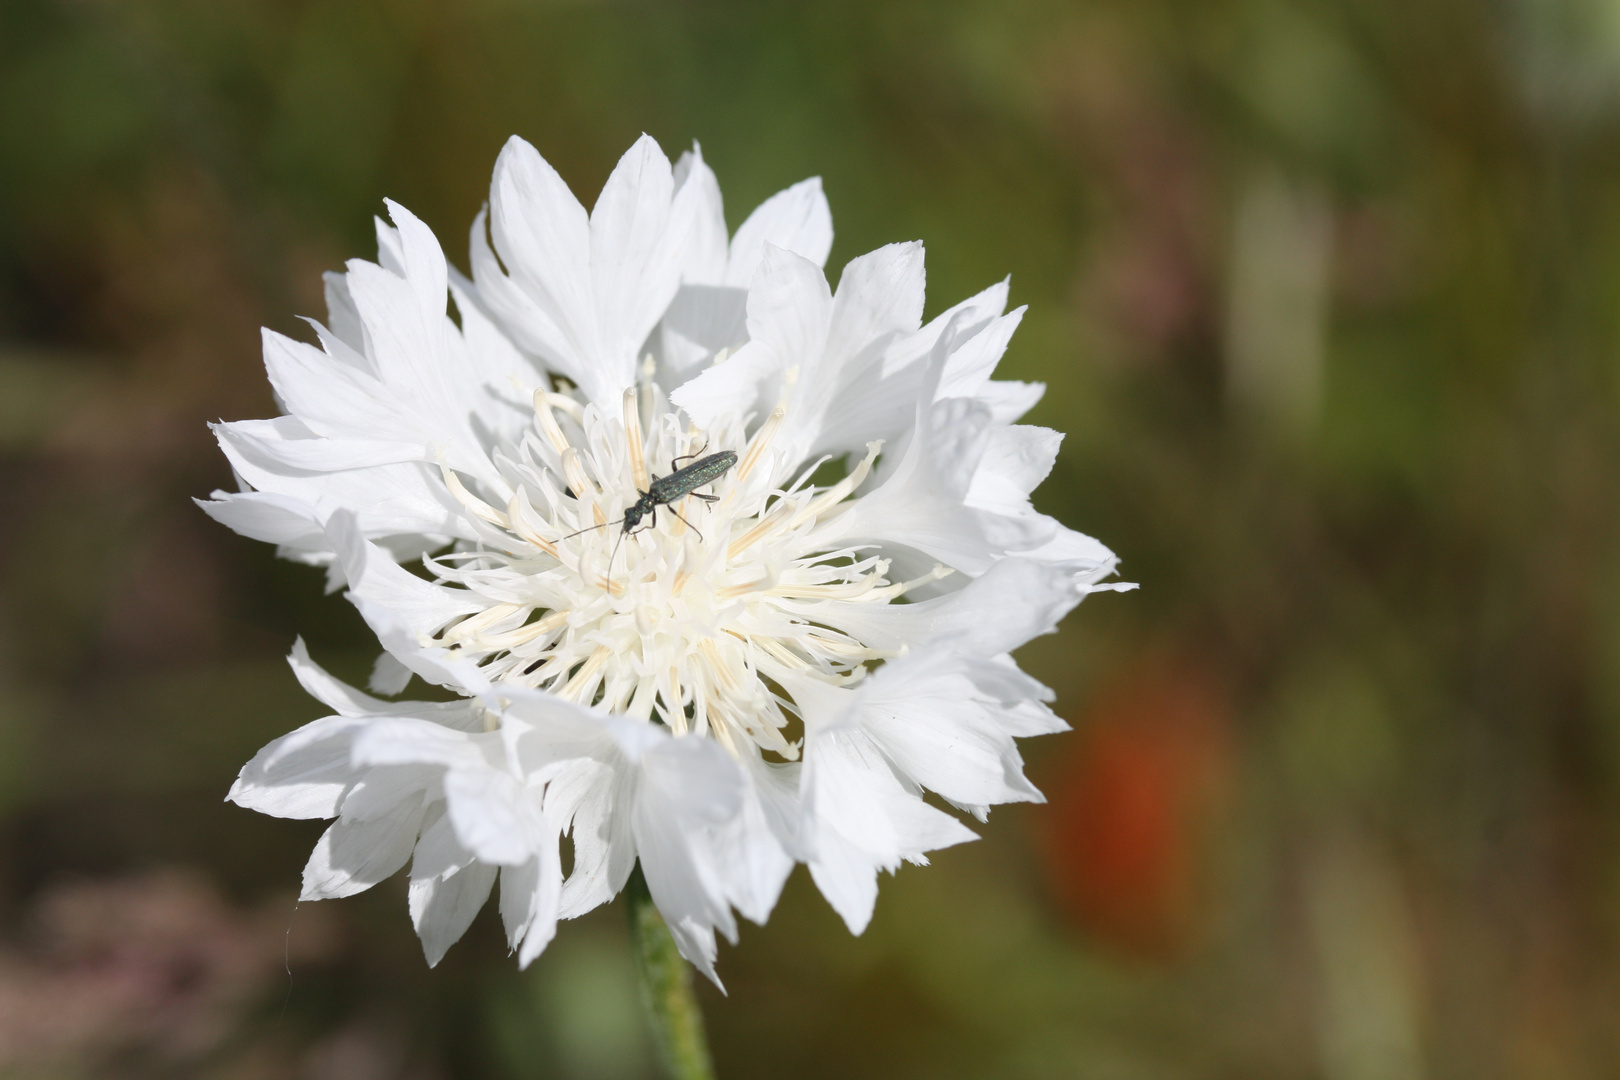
xmin=625 ymin=865 xmax=714 ymax=1080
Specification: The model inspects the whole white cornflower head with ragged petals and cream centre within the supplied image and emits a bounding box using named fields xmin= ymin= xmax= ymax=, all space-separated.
xmin=203 ymin=136 xmax=1116 ymax=978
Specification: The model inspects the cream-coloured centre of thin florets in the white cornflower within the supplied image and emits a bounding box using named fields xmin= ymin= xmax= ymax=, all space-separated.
xmin=424 ymin=387 xmax=949 ymax=759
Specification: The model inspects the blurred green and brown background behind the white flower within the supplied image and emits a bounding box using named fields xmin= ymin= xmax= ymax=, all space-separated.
xmin=0 ymin=0 xmax=1620 ymax=1080
